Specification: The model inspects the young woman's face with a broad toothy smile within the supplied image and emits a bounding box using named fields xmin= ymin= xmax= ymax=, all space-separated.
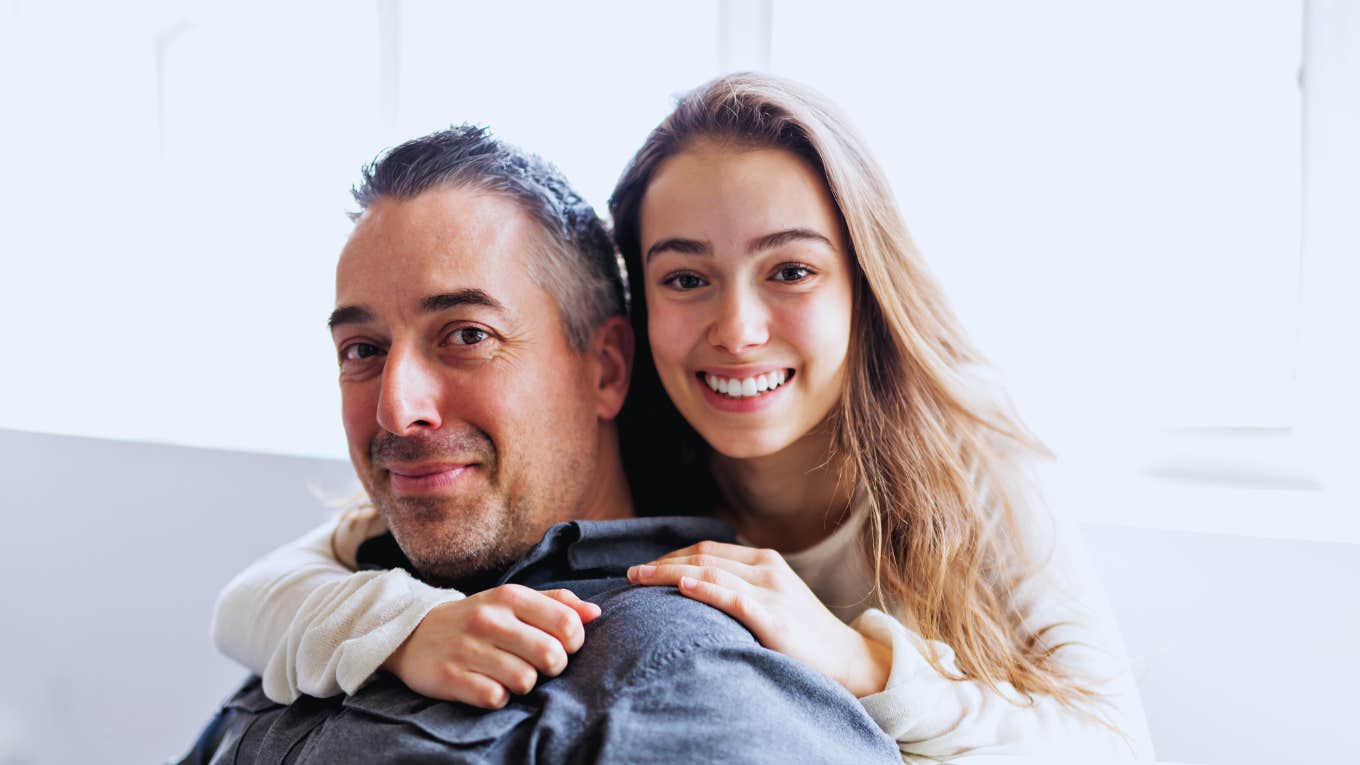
xmin=641 ymin=143 xmax=851 ymax=459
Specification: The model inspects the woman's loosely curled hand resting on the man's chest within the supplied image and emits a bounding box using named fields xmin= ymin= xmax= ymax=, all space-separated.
xmin=382 ymin=584 xmax=600 ymax=709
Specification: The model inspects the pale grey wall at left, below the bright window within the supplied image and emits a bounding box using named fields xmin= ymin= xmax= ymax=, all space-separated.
xmin=0 ymin=430 xmax=355 ymax=765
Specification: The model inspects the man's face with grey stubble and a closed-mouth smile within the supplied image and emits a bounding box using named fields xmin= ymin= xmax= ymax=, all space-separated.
xmin=332 ymin=188 xmax=600 ymax=580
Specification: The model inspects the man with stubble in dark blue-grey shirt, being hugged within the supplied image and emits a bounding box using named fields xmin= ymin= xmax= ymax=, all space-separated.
xmin=186 ymin=127 xmax=899 ymax=762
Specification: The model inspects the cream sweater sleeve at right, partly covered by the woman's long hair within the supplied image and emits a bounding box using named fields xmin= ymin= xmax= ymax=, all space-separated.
xmin=853 ymin=498 xmax=1152 ymax=762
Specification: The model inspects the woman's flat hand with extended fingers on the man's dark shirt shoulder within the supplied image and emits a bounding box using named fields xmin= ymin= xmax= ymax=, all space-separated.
xmin=628 ymin=542 xmax=892 ymax=697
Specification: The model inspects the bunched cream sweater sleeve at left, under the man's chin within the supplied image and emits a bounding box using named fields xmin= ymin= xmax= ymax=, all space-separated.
xmin=212 ymin=521 xmax=462 ymax=704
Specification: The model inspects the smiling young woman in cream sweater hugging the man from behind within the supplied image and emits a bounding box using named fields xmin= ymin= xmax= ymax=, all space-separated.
xmin=215 ymin=75 xmax=1151 ymax=758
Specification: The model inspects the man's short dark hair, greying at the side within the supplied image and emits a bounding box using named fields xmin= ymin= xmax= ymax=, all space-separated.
xmin=354 ymin=124 xmax=628 ymax=353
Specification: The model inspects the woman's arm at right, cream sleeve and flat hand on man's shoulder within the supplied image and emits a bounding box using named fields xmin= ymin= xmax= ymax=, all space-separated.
xmin=628 ymin=500 xmax=1152 ymax=761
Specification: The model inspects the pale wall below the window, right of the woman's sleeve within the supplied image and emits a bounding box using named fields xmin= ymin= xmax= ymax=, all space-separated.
xmin=1085 ymin=524 xmax=1360 ymax=765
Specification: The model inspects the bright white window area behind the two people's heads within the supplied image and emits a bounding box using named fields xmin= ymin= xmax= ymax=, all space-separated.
xmin=0 ymin=0 xmax=1360 ymax=542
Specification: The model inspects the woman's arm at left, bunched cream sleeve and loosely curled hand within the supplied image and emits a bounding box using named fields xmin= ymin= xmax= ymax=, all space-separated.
xmin=212 ymin=513 xmax=600 ymax=708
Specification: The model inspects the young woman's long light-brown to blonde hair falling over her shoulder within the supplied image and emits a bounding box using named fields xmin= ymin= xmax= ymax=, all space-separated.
xmin=609 ymin=74 xmax=1095 ymax=709
